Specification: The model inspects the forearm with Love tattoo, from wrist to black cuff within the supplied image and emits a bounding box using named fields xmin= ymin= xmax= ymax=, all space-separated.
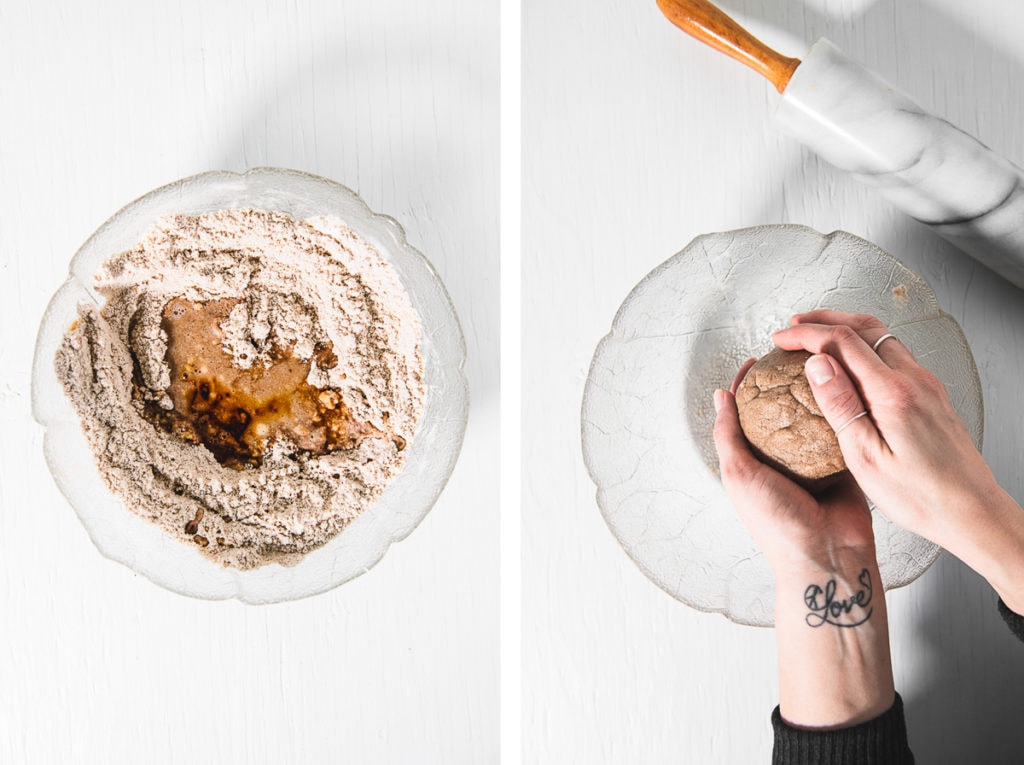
xmin=775 ymin=551 xmax=895 ymax=728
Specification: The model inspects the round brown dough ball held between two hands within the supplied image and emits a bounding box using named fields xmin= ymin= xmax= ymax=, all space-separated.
xmin=736 ymin=348 xmax=846 ymax=488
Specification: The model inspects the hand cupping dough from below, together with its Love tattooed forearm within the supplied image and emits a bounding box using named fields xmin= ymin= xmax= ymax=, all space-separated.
xmin=715 ymin=359 xmax=895 ymax=728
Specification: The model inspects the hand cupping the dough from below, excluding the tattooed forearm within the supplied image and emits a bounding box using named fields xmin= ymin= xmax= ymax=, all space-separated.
xmin=715 ymin=359 xmax=874 ymax=575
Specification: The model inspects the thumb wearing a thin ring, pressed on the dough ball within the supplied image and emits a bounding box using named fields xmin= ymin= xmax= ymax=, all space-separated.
xmin=804 ymin=353 xmax=882 ymax=462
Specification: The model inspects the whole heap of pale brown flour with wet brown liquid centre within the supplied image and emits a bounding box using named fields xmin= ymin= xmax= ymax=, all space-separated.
xmin=55 ymin=209 xmax=424 ymax=569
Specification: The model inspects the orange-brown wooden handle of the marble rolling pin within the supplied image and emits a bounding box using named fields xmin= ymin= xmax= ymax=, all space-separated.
xmin=657 ymin=0 xmax=800 ymax=93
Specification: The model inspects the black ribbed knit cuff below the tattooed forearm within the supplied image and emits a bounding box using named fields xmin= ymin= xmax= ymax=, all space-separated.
xmin=771 ymin=693 xmax=913 ymax=765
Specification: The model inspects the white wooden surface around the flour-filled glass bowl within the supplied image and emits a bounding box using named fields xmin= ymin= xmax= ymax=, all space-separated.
xmin=0 ymin=0 xmax=499 ymax=764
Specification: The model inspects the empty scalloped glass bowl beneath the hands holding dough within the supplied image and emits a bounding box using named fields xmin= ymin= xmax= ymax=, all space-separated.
xmin=583 ymin=225 xmax=983 ymax=626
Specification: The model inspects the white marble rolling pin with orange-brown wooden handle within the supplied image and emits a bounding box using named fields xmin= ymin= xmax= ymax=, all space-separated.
xmin=657 ymin=0 xmax=1024 ymax=287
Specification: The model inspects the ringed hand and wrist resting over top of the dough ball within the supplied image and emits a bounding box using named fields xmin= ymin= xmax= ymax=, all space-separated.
xmin=773 ymin=310 xmax=1024 ymax=613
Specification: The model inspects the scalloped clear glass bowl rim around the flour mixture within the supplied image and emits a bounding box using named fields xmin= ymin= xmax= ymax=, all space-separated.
xmin=32 ymin=168 xmax=469 ymax=603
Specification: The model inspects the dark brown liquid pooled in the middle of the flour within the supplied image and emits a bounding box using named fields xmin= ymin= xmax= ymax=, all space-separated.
xmin=137 ymin=298 xmax=406 ymax=470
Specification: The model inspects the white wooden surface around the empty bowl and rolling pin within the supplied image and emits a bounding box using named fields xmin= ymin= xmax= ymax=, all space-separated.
xmin=522 ymin=0 xmax=1024 ymax=765
